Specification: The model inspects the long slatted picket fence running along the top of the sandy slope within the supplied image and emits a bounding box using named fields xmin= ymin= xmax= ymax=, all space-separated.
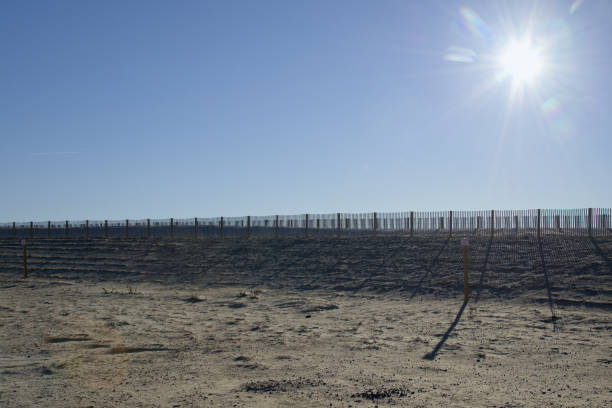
xmin=0 ymin=208 xmax=612 ymax=238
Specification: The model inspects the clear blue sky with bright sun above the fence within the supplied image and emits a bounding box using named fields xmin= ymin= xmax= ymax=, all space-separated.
xmin=0 ymin=0 xmax=612 ymax=221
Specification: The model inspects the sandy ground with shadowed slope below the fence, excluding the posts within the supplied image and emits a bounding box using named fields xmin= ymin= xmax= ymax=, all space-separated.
xmin=0 ymin=237 xmax=612 ymax=407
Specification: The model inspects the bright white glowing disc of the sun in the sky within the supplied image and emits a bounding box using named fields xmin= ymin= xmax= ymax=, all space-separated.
xmin=497 ymin=38 xmax=544 ymax=85
